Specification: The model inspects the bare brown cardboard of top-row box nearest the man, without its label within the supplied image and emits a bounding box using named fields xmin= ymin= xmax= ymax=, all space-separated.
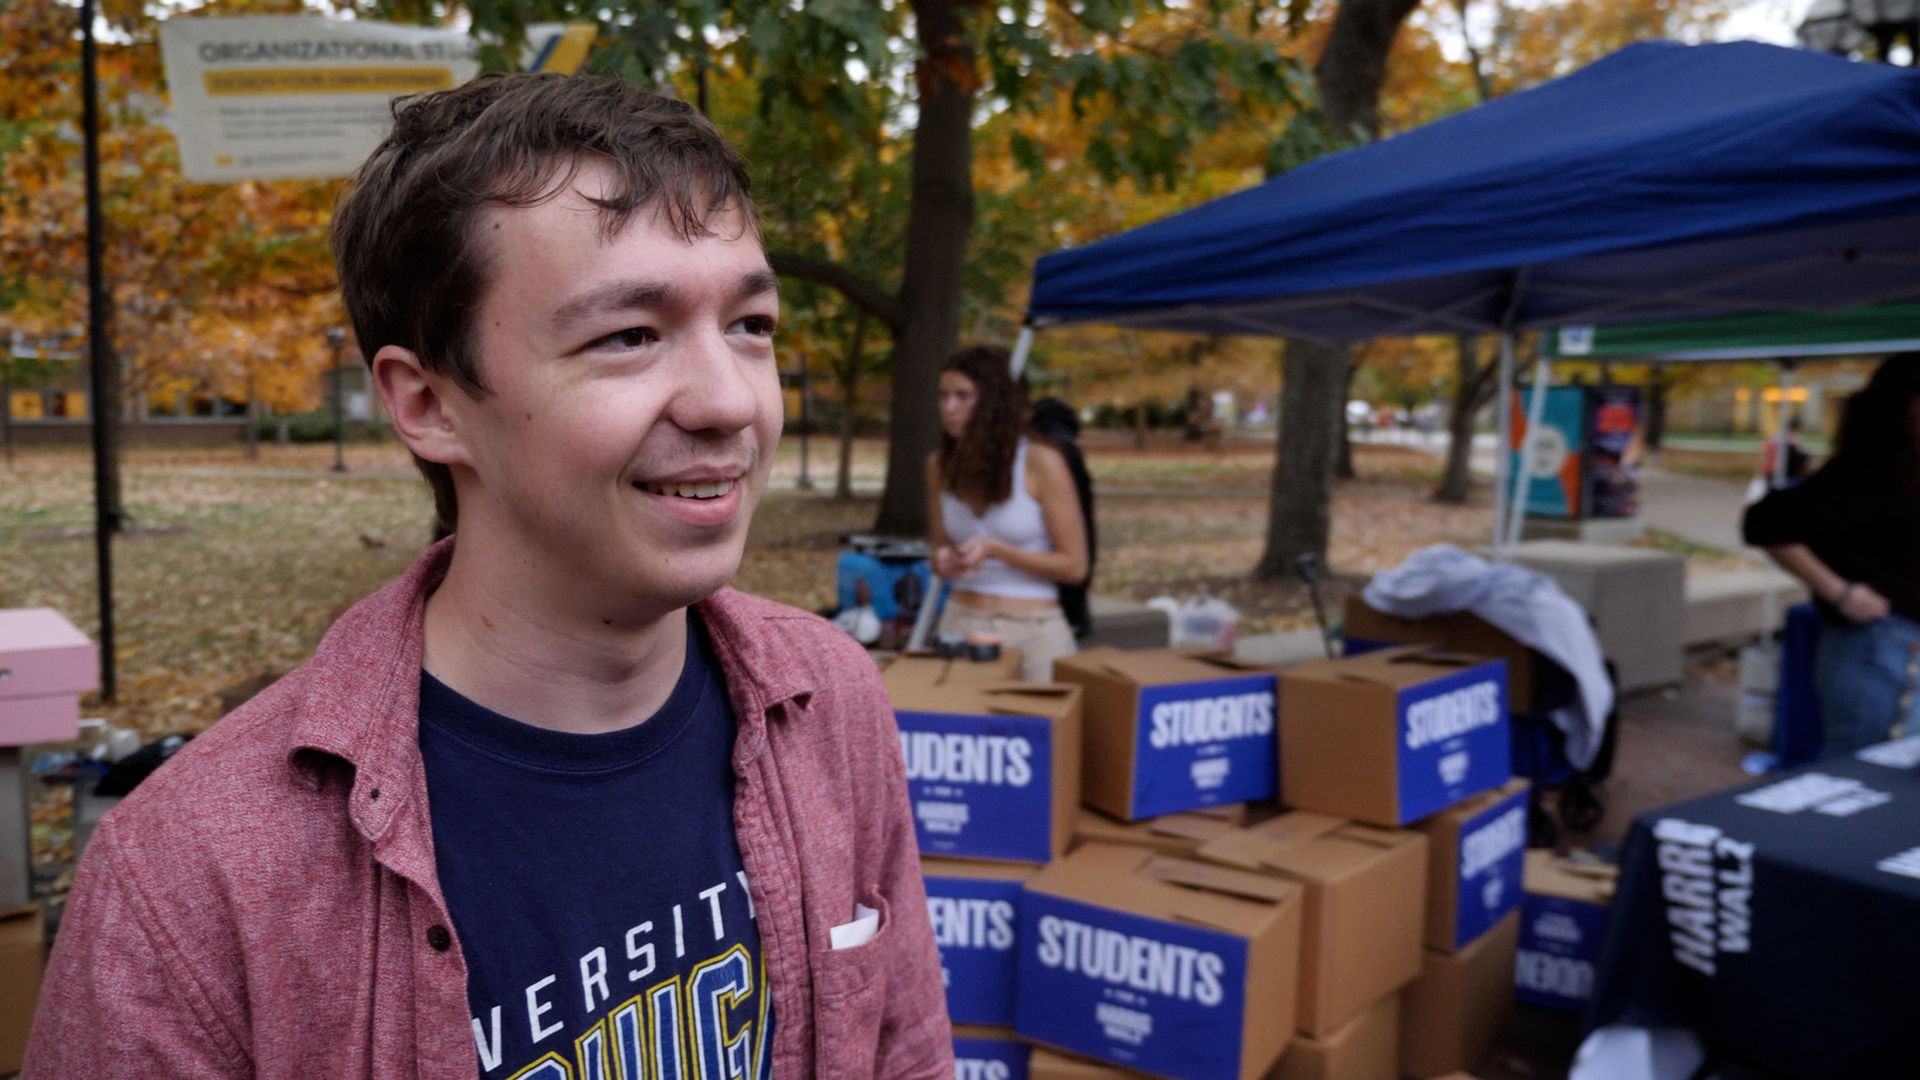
xmin=883 ymin=657 xmax=1081 ymax=863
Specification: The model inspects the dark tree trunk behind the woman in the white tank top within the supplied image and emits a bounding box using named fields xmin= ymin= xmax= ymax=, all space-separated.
xmin=874 ymin=0 xmax=979 ymax=536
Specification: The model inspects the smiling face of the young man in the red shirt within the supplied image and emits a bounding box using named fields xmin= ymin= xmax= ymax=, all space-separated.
xmin=442 ymin=163 xmax=781 ymax=619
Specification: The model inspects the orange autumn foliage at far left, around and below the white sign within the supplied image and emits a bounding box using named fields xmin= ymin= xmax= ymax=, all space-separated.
xmin=0 ymin=0 xmax=340 ymax=449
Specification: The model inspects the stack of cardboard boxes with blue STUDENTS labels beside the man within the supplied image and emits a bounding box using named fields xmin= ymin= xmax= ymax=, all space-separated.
xmin=887 ymin=630 xmax=1566 ymax=1080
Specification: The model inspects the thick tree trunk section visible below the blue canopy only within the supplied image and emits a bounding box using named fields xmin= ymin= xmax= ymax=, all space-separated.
xmin=1254 ymin=338 xmax=1350 ymax=578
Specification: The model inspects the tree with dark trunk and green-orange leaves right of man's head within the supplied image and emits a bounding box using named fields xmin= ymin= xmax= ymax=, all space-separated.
xmin=447 ymin=0 xmax=1290 ymax=534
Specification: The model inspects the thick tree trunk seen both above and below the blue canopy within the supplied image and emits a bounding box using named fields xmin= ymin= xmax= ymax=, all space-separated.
xmin=1254 ymin=0 xmax=1419 ymax=578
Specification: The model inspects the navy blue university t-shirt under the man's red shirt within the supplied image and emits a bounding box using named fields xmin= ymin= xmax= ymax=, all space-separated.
xmin=420 ymin=613 xmax=774 ymax=1080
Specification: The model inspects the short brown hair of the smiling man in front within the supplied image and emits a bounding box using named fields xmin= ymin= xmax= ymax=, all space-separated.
xmin=332 ymin=73 xmax=758 ymax=528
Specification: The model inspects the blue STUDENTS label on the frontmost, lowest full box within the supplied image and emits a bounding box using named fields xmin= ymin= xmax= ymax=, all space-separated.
xmin=1014 ymin=890 xmax=1246 ymax=1080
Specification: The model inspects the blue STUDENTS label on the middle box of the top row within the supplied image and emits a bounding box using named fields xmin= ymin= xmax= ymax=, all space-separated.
xmin=1133 ymin=675 xmax=1281 ymax=821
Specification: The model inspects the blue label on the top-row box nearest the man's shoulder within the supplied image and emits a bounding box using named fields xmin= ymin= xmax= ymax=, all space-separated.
xmin=895 ymin=713 xmax=1054 ymax=863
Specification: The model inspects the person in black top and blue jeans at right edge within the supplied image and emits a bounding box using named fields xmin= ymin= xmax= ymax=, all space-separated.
xmin=1743 ymin=352 xmax=1920 ymax=755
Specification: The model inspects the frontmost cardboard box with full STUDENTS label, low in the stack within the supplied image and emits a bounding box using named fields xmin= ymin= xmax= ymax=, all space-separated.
xmin=1014 ymin=844 xmax=1302 ymax=1080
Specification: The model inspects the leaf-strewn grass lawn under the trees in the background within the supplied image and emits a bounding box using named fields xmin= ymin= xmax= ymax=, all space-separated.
xmin=0 ymin=432 xmax=1490 ymax=736
